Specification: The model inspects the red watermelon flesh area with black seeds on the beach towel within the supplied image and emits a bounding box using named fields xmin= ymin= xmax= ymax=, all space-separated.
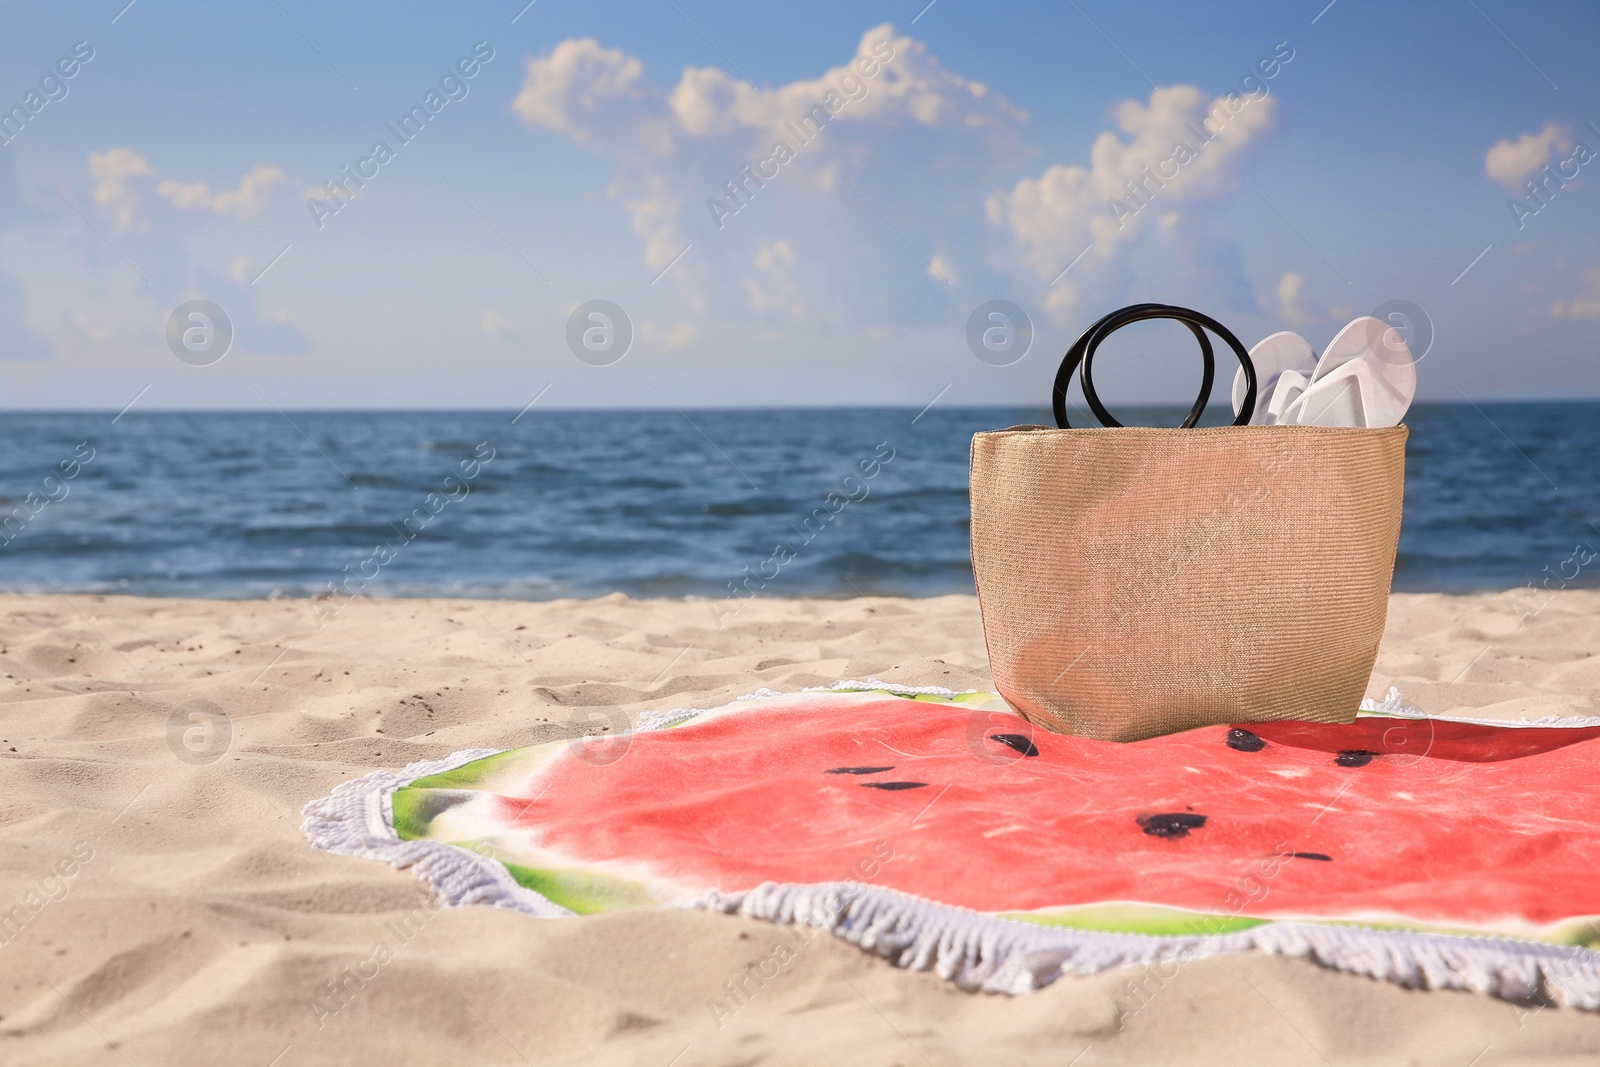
xmin=395 ymin=693 xmax=1600 ymax=929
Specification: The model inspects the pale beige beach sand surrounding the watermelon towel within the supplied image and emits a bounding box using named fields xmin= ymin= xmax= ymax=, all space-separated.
xmin=0 ymin=592 xmax=1600 ymax=1067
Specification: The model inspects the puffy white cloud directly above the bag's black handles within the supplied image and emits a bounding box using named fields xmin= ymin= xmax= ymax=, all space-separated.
xmin=987 ymin=85 xmax=1275 ymax=319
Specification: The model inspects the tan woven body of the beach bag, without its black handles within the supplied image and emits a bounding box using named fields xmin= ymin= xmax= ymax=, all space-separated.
xmin=971 ymin=426 xmax=1406 ymax=741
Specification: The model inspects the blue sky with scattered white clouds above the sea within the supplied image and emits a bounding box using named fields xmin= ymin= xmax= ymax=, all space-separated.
xmin=0 ymin=0 xmax=1600 ymax=410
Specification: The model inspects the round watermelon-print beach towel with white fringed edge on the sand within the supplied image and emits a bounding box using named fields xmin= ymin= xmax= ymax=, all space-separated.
xmin=304 ymin=681 xmax=1600 ymax=1009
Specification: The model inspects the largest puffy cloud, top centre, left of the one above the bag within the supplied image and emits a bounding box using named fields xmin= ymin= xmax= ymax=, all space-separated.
xmin=514 ymin=24 xmax=1026 ymax=320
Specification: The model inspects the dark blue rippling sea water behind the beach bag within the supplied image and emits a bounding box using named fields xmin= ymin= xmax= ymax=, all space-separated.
xmin=0 ymin=403 xmax=1600 ymax=598
